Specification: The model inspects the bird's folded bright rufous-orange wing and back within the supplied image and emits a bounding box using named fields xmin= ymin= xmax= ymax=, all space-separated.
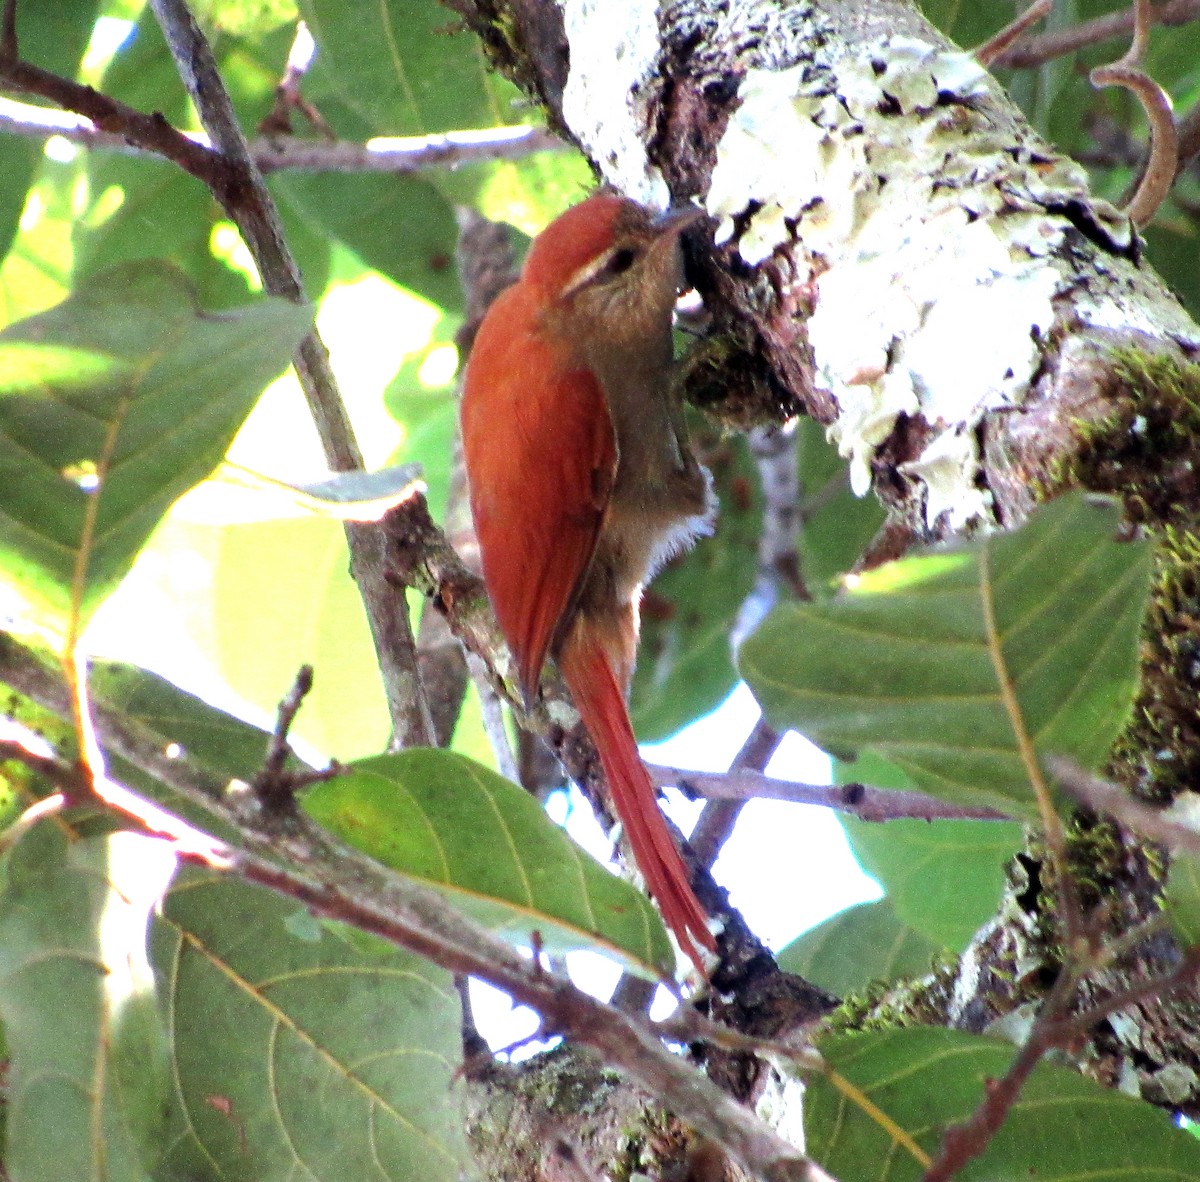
xmin=462 ymin=284 xmax=617 ymax=697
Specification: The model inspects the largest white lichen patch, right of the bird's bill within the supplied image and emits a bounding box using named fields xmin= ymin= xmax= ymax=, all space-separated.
xmin=707 ymin=30 xmax=1128 ymax=527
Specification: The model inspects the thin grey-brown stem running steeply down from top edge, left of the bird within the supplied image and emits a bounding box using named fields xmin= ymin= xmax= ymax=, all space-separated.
xmin=151 ymin=0 xmax=434 ymax=746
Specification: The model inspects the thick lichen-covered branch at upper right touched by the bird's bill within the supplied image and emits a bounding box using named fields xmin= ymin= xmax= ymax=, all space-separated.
xmin=463 ymin=0 xmax=1200 ymax=538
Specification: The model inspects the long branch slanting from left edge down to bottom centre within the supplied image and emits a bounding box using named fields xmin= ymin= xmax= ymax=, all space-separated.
xmin=0 ymin=634 xmax=829 ymax=1182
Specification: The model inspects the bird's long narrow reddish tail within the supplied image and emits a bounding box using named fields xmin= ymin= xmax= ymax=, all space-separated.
xmin=558 ymin=622 xmax=716 ymax=976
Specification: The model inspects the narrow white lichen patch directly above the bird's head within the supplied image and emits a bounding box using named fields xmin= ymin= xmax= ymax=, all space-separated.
xmin=563 ymin=0 xmax=670 ymax=209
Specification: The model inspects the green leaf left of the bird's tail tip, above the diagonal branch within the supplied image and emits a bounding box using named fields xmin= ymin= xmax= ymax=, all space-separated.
xmin=304 ymin=749 xmax=674 ymax=976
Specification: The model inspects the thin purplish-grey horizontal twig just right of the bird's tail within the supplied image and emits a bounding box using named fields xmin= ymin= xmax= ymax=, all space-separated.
xmin=647 ymin=764 xmax=1012 ymax=821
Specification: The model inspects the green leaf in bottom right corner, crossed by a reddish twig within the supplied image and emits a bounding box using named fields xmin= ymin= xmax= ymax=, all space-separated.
xmin=804 ymin=1027 xmax=1200 ymax=1182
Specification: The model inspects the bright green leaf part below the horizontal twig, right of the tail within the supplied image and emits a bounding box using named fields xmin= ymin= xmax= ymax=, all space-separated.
xmin=840 ymin=817 xmax=1024 ymax=953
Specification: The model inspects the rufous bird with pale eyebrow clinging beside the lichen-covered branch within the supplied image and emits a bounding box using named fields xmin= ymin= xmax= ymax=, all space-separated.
xmin=460 ymin=190 xmax=715 ymax=977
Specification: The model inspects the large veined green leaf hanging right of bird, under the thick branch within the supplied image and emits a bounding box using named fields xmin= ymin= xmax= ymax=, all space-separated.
xmin=739 ymin=496 xmax=1151 ymax=820
